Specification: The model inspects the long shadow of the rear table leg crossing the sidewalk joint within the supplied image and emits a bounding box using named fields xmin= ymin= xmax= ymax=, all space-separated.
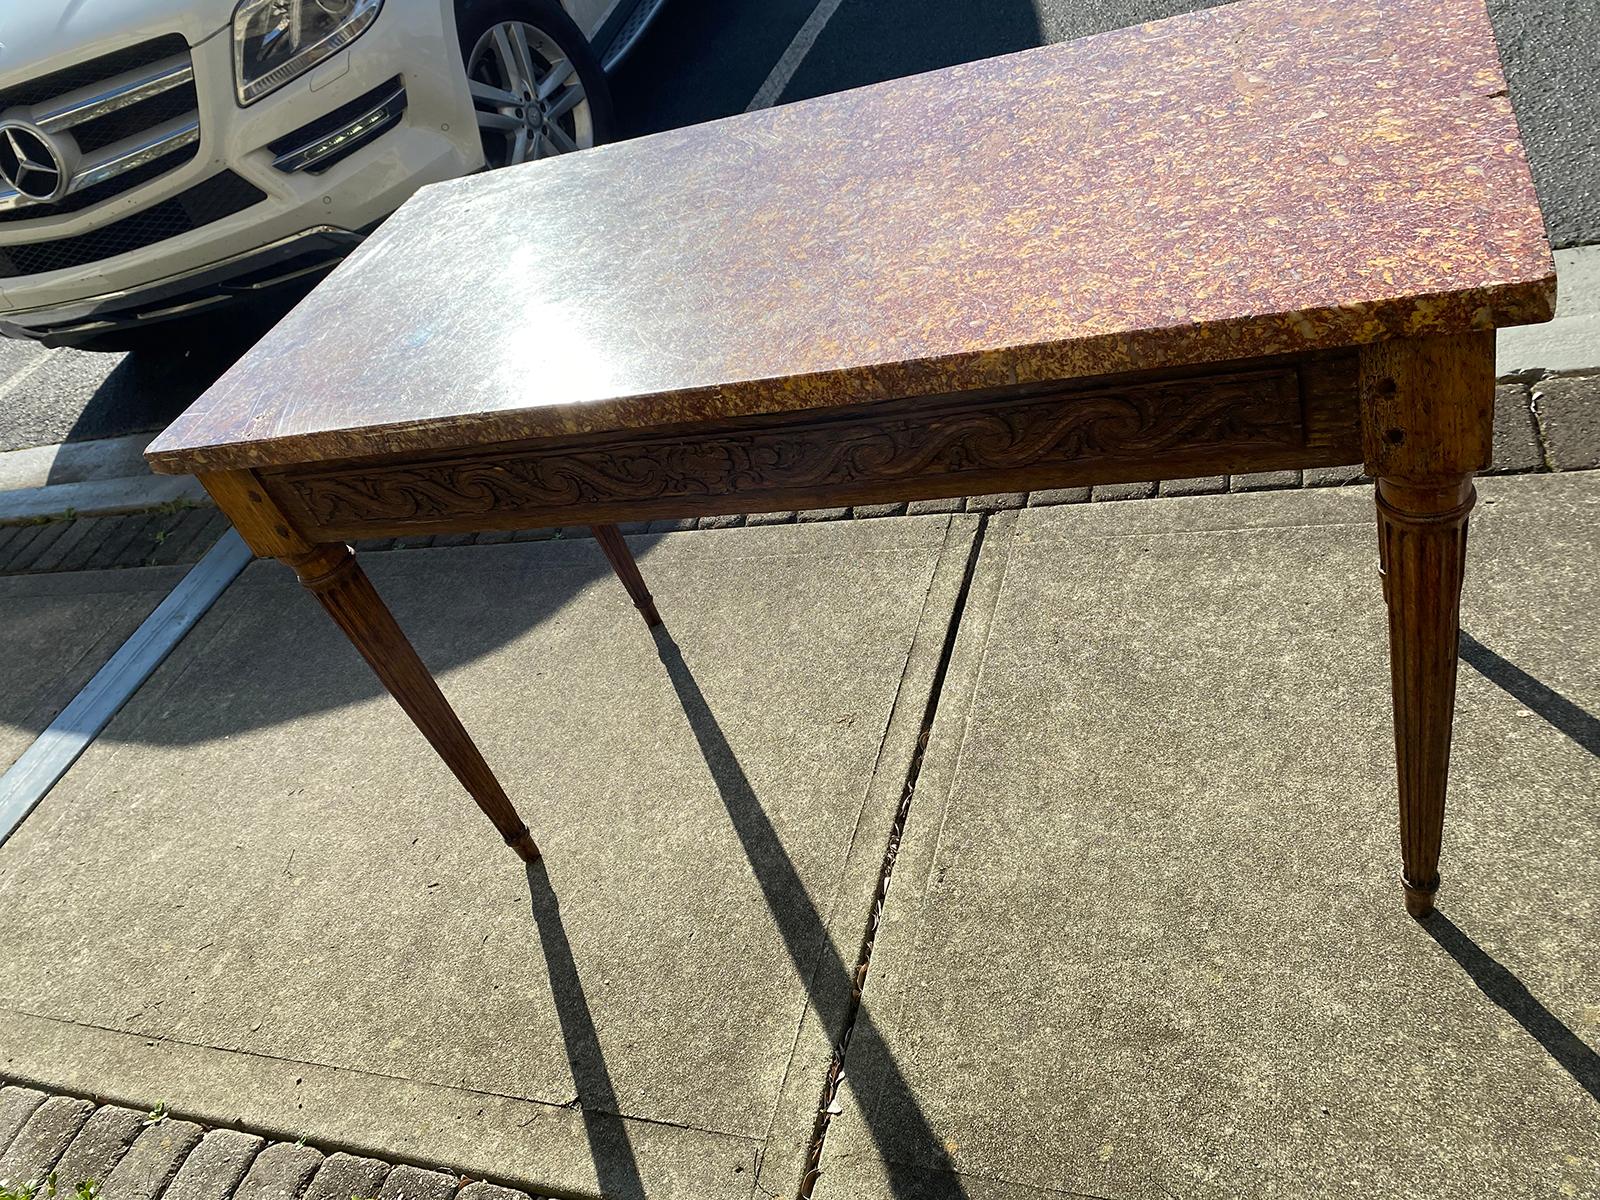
xmin=653 ymin=626 xmax=966 ymax=1200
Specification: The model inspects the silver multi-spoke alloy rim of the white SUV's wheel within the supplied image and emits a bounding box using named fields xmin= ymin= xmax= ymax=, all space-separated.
xmin=467 ymin=21 xmax=595 ymax=166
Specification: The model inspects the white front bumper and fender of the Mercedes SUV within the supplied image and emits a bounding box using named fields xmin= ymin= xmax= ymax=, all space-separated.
xmin=0 ymin=0 xmax=483 ymax=346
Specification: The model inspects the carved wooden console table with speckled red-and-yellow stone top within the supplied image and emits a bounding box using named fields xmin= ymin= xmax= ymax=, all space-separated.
xmin=149 ymin=0 xmax=1554 ymax=915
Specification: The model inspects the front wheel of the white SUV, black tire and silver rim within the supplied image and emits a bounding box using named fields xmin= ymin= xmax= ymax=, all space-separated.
xmin=456 ymin=0 xmax=613 ymax=168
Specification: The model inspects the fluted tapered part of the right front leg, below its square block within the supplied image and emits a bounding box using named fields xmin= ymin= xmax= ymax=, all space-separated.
xmin=1378 ymin=478 xmax=1475 ymax=917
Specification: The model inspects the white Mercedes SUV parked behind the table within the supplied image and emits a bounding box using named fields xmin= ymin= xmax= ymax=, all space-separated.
xmin=0 ymin=0 xmax=662 ymax=349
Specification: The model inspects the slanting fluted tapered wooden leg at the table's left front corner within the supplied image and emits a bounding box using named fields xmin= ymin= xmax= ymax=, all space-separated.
xmin=282 ymin=544 xmax=539 ymax=862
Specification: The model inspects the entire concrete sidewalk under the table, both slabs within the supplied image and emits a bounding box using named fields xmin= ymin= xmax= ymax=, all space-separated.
xmin=0 ymin=472 xmax=1600 ymax=1200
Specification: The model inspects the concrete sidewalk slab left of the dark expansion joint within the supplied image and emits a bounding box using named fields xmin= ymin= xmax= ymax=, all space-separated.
xmin=0 ymin=515 xmax=978 ymax=1200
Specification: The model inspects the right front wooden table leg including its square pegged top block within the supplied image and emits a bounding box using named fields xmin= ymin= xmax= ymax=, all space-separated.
xmin=1362 ymin=333 xmax=1494 ymax=918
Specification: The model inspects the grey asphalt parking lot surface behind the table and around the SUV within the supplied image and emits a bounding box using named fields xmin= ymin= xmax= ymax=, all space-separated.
xmin=0 ymin=0 xmax=1600 ymax=451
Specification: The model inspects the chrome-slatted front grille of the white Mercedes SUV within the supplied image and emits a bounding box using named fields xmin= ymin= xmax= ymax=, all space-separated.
xmin=0 ymin=34 xmax=200 ymax=222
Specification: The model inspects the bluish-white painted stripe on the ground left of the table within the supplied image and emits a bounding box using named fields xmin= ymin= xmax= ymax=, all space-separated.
xmin=0 ymin=530 xmax=251 ymax=842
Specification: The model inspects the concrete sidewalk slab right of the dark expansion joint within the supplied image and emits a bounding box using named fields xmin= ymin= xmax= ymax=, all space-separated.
xmin=816 ymin=474 xmax=1600 ymax=1200
